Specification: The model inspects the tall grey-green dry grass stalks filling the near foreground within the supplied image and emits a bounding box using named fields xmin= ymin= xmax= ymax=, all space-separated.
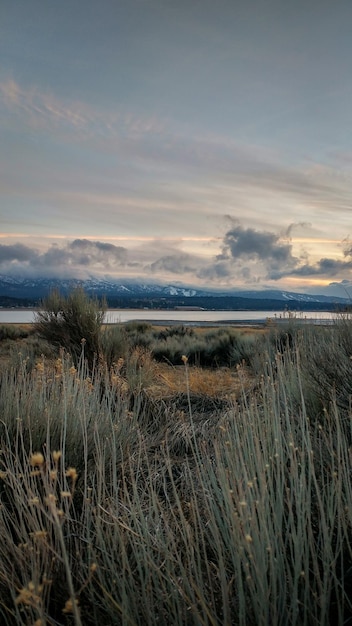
xmin=0 ymin=342 xmax=352 ymax=626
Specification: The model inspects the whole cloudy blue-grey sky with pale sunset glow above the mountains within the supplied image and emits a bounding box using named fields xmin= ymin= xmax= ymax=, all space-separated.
xmin=0 ymin=0 xmax=352 ymax=297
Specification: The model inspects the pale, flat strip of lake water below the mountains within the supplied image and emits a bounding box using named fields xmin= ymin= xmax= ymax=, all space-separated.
xmin=0 ymin=309 xmax=336 ymax=325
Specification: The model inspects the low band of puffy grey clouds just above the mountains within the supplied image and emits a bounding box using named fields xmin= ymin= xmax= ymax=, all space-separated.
xmin=0 ymin=224 xmax=352 ymax=288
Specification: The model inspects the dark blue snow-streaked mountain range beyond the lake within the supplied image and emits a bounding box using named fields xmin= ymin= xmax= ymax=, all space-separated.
xmin=0 ymin=275 xmax=350 ymax=310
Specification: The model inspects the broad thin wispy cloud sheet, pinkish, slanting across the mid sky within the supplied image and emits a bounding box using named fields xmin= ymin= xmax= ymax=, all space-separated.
xmin=0 ymin=79 xmax=352 ymax=243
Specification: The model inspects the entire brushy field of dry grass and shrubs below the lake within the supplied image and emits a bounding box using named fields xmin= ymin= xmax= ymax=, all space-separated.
xmin=0 ymin=302 xmax=352 ymax=626
